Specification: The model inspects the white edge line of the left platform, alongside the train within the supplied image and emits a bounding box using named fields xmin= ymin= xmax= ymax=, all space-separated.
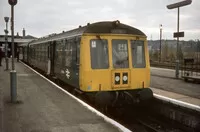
xmin=20 ymin=61 xmax=132 ymax=132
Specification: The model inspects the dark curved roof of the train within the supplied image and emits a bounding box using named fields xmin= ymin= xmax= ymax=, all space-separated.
xmin=30 ymin=20 xmax=146 ymax=44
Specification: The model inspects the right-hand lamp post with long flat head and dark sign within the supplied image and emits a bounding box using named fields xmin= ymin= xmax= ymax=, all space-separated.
xmin=167 ymin=0 xmax=192 ymax=78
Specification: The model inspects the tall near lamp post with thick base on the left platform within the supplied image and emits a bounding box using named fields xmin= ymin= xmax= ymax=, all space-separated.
xmin=8 ymin=0 xmax=17 ymax=103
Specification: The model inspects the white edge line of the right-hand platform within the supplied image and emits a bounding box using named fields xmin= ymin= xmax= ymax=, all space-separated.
xmin=153 ymin=93 xmax=200 ymax=112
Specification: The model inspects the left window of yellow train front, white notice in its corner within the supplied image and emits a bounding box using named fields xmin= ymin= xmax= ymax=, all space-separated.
xmin=90 ymin=39 xmax=109 ymax=69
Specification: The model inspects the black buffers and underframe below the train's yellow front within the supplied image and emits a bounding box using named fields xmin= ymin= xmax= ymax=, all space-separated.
xmin=86 ymin=88 xmax=153 ymax=107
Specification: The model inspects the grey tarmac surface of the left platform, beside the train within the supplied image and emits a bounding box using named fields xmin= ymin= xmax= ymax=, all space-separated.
xmin=0 ymin=63 xmax=128 ymax=132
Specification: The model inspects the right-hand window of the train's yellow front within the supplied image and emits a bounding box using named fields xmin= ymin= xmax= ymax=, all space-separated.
xmin=131 ymin=40 xmax=146 ymax=68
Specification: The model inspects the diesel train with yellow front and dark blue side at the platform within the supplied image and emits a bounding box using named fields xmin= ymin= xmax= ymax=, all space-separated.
xmin=22 ymin=21 xmax=153 ymax=105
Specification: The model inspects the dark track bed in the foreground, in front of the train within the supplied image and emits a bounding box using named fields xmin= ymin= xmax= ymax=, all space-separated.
xmin=107 ymin=104 xmax=188 ymax=132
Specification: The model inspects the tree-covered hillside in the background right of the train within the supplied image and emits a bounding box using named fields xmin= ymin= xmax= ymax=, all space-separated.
xmin=148 ymin=40 xmax=200 ymax=62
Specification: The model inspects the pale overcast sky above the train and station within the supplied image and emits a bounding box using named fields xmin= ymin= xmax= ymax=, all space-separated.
xmin=0 ymin=0 xmax=200 ymax=40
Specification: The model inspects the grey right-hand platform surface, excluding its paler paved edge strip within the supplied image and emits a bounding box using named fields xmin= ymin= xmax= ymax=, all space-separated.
xmin=150 ymin=67 xmax=200 ymax=99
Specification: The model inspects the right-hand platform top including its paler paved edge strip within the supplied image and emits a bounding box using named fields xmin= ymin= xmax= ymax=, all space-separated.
xmin=150 ymin=67 xmax=200 ymax=106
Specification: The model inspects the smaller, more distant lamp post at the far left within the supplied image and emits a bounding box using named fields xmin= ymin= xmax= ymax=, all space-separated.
xmin=4 ymin=17 xmax=9 ymax=71
